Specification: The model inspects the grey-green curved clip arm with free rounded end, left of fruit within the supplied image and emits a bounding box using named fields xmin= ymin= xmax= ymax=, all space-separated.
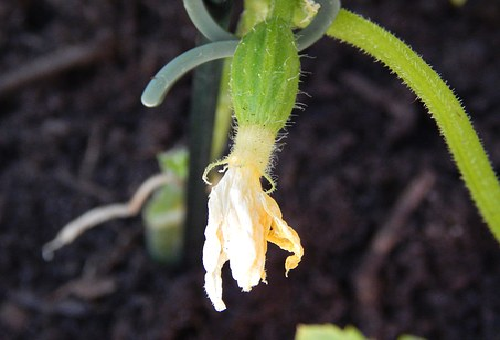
xmin=141 ymin=40 xmax=238 ymax=107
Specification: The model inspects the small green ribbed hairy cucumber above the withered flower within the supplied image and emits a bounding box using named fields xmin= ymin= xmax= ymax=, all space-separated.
xmin=231 ymin=18 xmax=300 ymax=133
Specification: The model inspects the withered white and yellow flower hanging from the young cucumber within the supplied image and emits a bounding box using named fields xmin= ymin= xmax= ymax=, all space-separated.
xmin=203 ymin=125 xmax=304 ymax=311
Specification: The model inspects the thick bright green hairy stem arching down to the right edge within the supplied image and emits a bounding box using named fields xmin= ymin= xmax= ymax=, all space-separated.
xmin=327 ymin=9 xmax=500 ymax=242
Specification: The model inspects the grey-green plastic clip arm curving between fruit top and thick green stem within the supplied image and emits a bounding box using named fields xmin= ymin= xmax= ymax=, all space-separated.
xmin=295 ymin=0 xmax=340 ymax=51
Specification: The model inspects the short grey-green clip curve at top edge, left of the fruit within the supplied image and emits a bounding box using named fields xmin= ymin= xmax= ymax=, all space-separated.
xmin=184 ymin=0 xmax=238 ymax=41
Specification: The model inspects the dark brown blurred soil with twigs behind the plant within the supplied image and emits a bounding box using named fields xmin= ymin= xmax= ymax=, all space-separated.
xmin=0 ymin=0 xmax=500 ymax=339
